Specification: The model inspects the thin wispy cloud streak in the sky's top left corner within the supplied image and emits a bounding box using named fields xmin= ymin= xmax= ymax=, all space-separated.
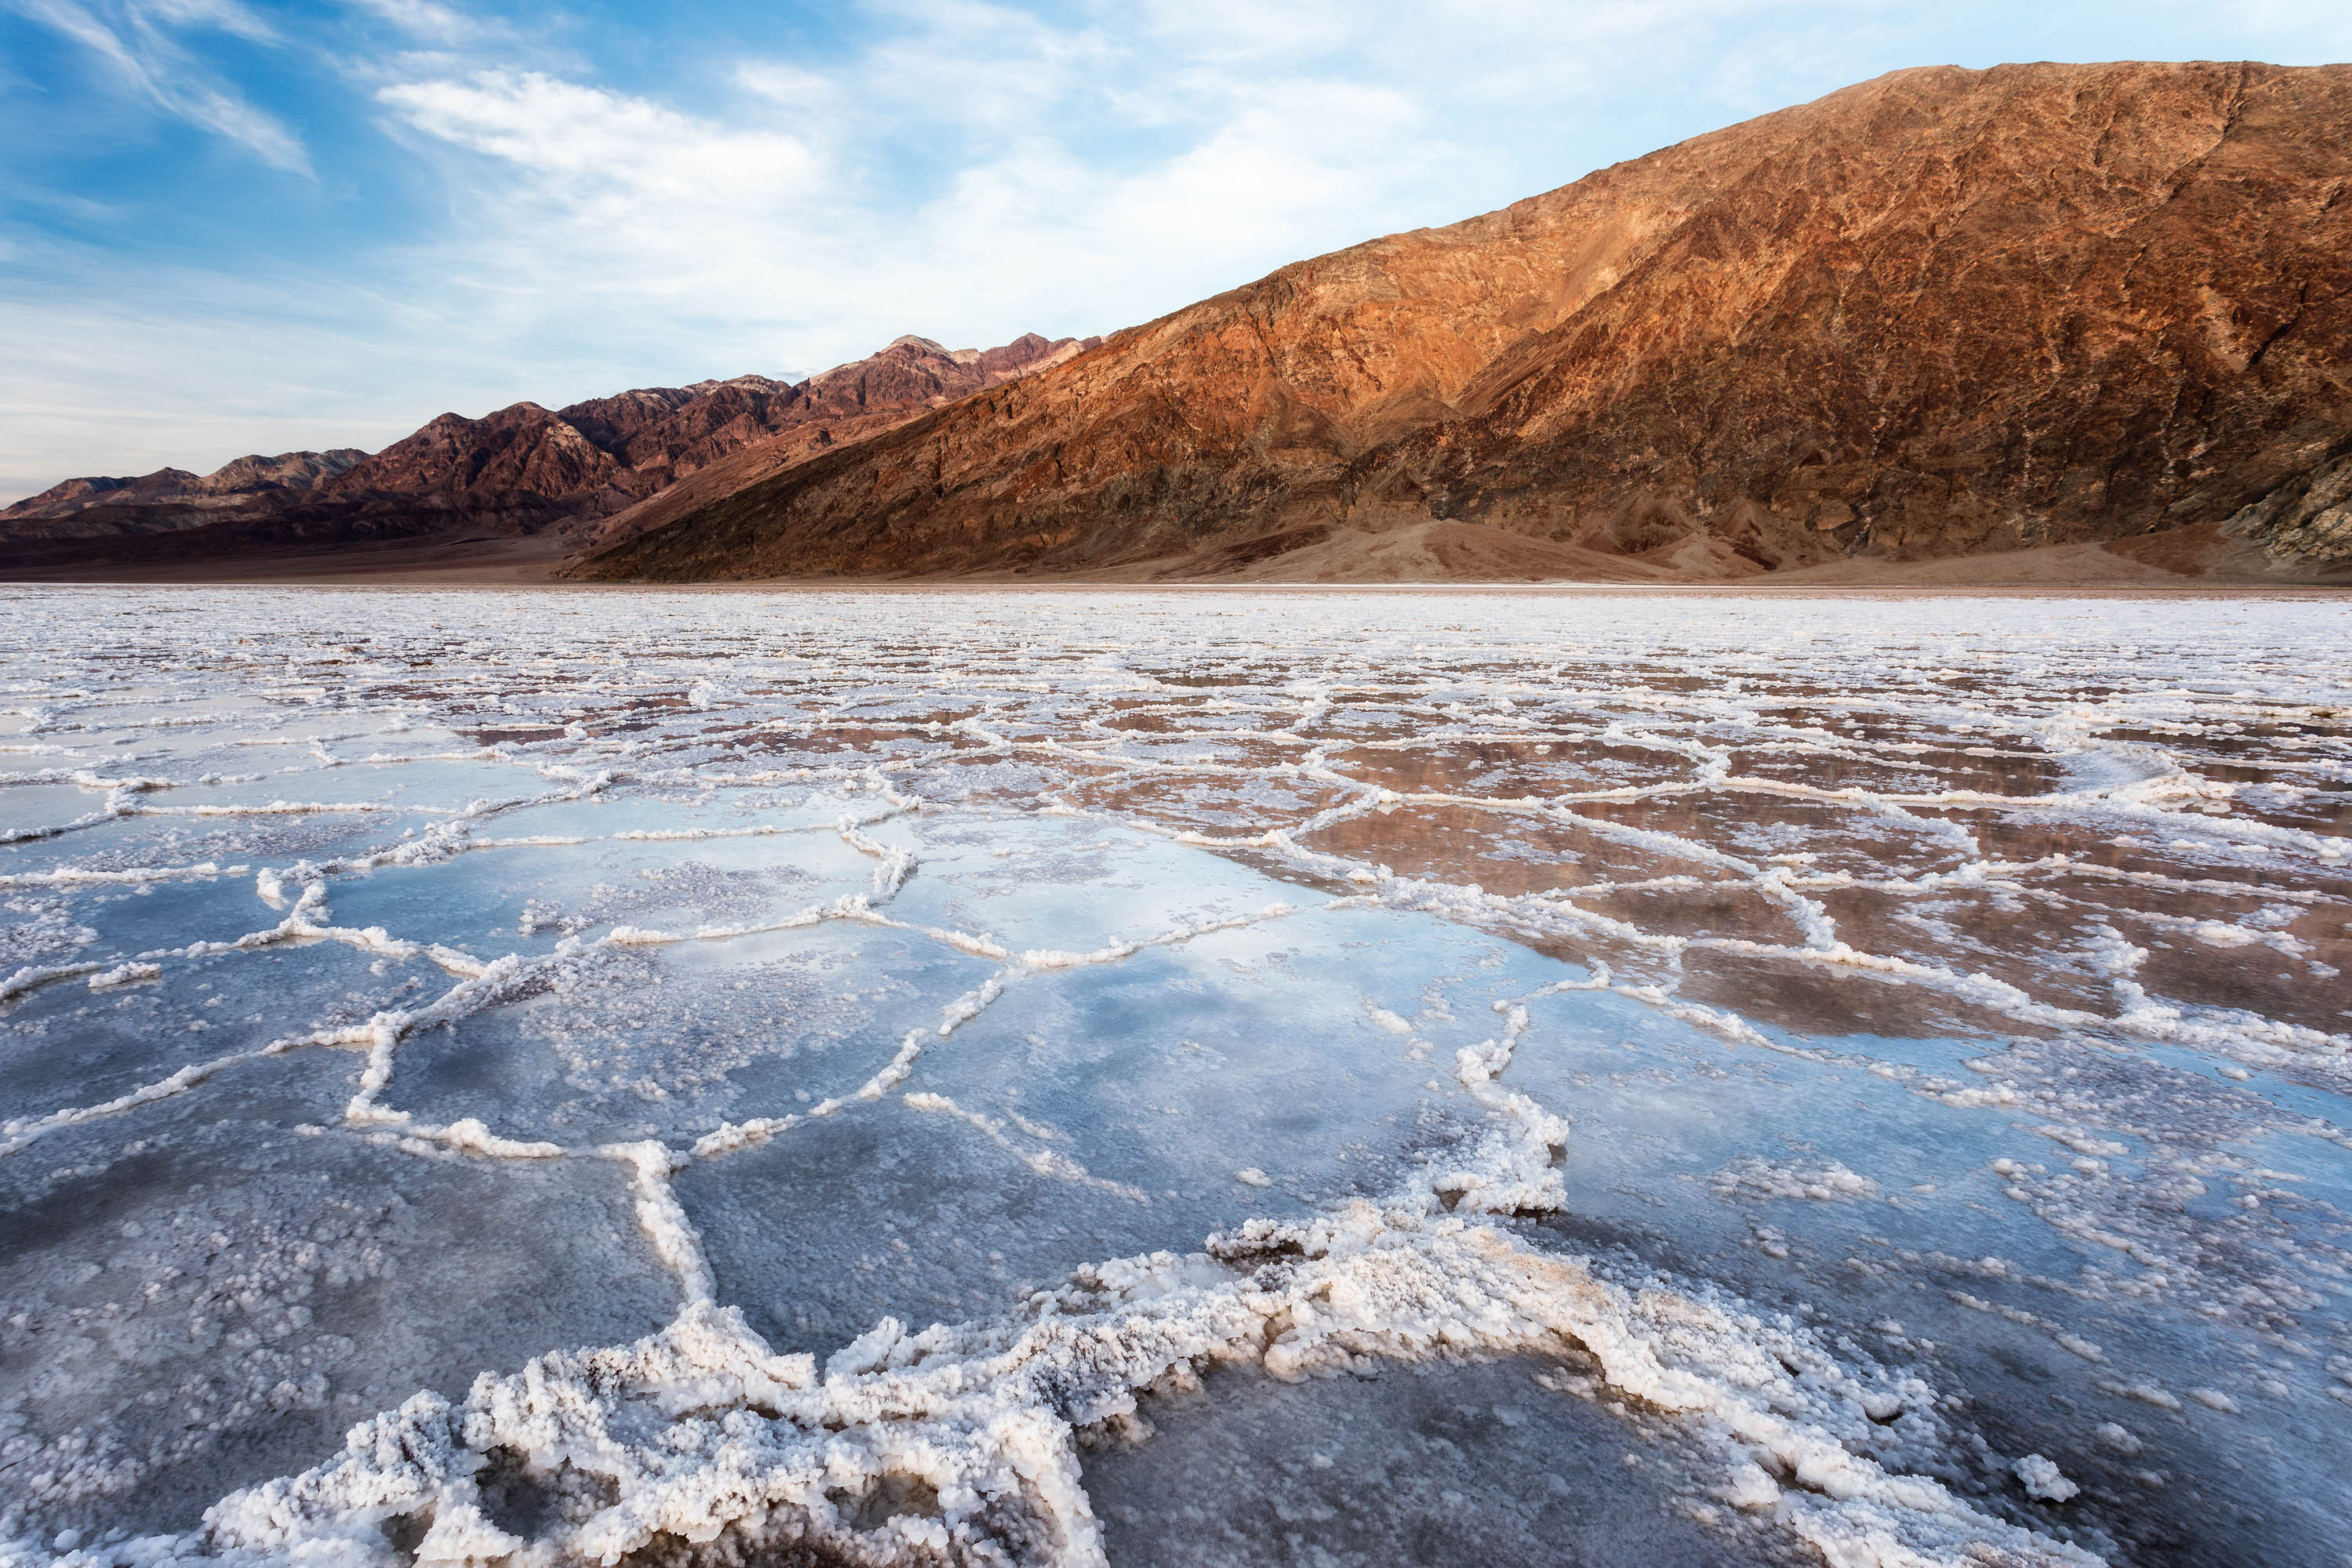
xmin=12 ymin=0 xmax=310 ymax=174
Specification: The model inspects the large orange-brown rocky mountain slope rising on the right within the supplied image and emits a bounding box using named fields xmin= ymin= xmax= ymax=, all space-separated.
xmin=574 ymin=64 xmax=2352 ymax=581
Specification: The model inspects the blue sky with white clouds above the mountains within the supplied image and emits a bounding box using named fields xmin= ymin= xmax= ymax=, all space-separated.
xmin=0 ymin=0 xmax=2352 ymax=501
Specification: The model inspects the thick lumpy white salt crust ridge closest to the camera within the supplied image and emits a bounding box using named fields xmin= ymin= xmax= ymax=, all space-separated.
xmin=13 ymin=1133 xmax=2100 ymax=1568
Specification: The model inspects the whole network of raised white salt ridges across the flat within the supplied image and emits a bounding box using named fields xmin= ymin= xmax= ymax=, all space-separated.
xmin=0 ymin=592 xmax=2352 ymax=1566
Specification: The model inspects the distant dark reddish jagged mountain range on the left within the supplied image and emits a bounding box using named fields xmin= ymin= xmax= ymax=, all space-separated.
xmin=0 ymin=334 xmax=1082 ymax=572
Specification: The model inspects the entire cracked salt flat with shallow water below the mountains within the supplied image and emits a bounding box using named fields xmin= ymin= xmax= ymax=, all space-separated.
xmin=0 ymin=588 xmax=2352 ymax=1568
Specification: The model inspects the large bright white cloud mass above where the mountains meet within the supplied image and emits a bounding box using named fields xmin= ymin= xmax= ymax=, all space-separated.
xmin=346 ymin=0 xmax=1468 ymax=374
